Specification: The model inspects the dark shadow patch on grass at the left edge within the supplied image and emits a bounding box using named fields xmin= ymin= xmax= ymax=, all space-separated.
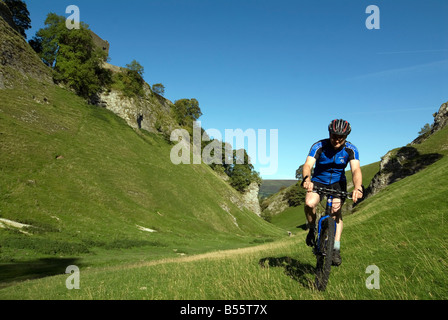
xmin=0 ymin=258 xmax=80 ymax=288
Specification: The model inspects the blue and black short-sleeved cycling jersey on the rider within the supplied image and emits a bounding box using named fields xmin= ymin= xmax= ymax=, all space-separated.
xmin=309 ymin=139 xmax=359 ymax=184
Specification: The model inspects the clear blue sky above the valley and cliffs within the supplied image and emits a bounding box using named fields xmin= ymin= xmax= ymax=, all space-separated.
xmin=26 ymin=0 xmax=448 ymax=179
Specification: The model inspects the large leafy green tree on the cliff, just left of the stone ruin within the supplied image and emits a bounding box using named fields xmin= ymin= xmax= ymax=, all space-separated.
xmin=30 ymin=13 xmax=110 ymax=100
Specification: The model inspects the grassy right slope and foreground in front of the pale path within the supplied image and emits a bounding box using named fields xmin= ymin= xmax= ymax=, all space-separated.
xmin=0 ymin=122 xmax=448 ymax=300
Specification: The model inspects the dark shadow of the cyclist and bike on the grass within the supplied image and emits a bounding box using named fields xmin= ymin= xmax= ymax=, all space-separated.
xmin=258 ymin=257 xmax=315 ymax=290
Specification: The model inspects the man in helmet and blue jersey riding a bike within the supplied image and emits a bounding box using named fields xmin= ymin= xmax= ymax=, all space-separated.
xmin=302 ymin=119 xmax=363 ymax=266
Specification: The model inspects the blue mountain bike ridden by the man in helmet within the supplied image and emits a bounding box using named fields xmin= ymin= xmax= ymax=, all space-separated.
xmin=302 ymin=178 xmax=351 ymax=291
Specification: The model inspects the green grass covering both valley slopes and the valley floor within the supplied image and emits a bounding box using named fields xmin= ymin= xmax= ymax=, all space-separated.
xmin=0 ymin=57 xmax=448 ymax=300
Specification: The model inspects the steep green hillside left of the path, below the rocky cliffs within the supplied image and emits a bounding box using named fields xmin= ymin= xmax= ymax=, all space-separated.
xmin=0 ymin=75 xmax=283 ymax=272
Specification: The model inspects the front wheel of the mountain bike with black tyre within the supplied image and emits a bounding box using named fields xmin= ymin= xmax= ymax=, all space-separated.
xmin=315 ymin=217 xmax=336 ymax=291
